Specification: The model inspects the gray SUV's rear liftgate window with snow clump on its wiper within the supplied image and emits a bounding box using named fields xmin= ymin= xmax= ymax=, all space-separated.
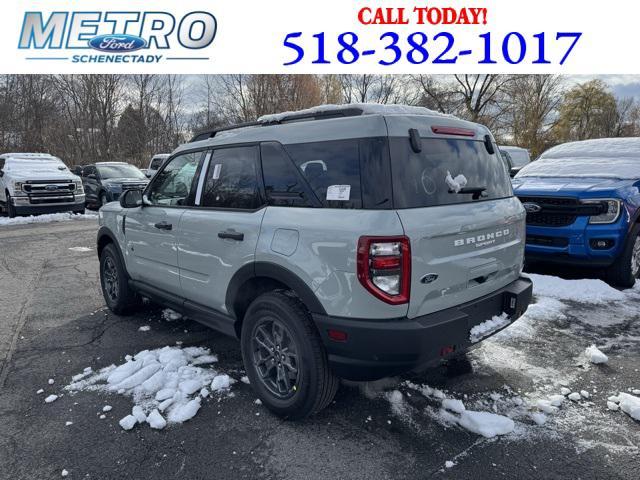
xmin=390 ymin=138 xmax=513 ymax=208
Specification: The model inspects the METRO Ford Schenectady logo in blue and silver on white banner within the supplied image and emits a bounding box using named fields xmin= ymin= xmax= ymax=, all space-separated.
xmin=18 ymin=11 xmax=217 ymax=63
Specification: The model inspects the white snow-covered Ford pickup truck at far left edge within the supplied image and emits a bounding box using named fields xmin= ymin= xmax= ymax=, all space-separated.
xmin=0 ymin=153 xmax=85 ymax=218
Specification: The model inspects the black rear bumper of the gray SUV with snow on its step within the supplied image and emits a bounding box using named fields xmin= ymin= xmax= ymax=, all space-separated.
xmin=313 ymin=277 xmax=532 ymax=381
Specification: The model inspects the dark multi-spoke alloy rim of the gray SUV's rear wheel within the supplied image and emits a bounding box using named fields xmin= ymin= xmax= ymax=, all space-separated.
xmin=251 ymin=317 xmax=300 ymax=399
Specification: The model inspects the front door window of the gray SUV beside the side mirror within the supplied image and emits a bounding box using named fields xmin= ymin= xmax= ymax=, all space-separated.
xmin=147 ymin=152 xmax=202 ymax=206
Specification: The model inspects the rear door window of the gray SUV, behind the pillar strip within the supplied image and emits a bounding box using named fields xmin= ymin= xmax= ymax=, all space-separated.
xmin=200 ymin=147 xmax=261 ymax=210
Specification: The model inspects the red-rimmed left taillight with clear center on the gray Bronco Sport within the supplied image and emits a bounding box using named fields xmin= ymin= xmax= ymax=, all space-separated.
xmin=357 ymin=236 xmax=411 ymax=305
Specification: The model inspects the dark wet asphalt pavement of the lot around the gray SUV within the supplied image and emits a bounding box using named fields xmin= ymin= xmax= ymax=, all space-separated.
xmin=0 ymin=220 xmax=640 ymax=480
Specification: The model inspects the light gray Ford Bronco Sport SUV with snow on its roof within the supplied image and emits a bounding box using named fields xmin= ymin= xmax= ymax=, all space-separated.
xmin=98 ymin=105 xmax=532 ymax=418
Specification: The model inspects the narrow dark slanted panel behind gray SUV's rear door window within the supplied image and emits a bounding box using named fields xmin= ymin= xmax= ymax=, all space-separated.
xmin=260 ymin=143 xmax=312 ymax=207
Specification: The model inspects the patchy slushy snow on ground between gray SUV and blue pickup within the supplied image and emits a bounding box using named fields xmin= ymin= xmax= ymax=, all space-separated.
xmin=376 ymin=275 xmax=640 ymax=454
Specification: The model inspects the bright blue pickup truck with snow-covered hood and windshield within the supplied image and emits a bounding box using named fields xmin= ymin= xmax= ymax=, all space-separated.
xmin=513 ymin=138 xmax=640 ymax=288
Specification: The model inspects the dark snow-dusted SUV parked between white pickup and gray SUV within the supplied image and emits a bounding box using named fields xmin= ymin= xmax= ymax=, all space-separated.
xmin=82 ymin=162 xmax=149 ymax=208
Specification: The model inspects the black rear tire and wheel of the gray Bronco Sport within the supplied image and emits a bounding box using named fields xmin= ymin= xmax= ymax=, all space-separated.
xmin=240 ymin=291 xmax=338 ymax=420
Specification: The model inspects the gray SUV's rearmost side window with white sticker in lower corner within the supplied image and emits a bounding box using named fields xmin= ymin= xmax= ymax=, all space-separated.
xmin=285 ymin=140 xmax=362 ymax=208
